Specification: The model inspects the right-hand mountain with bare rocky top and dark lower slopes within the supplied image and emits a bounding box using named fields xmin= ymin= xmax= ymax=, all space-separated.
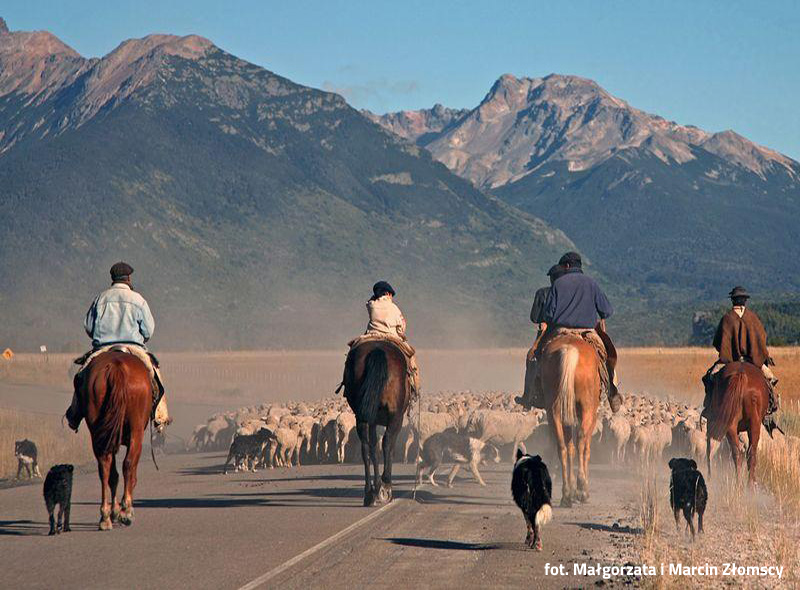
xmin=372 ymin=74 xmax=800 ymax=315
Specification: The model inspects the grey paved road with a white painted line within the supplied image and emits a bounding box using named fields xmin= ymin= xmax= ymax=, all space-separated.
xmin=0 ymin=454 xmax=638 ymax=588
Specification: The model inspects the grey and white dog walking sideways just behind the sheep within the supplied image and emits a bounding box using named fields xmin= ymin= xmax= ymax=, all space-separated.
xmin=417 ymin=428 xmax=500 ymax=488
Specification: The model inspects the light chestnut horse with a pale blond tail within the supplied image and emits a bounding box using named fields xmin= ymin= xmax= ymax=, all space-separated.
xmin=541 ymin=335 xmax=600 ymax=507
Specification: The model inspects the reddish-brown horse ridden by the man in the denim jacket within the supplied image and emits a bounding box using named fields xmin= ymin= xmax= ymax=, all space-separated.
xmin=77 ymin=351 xmax=153 ymax=531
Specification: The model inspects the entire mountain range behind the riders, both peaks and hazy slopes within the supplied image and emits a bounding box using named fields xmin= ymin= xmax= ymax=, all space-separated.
xmin=0 ymin=19 xmax=800 ymax=350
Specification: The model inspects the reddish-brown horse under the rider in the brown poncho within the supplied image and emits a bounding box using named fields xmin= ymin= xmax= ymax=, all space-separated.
xmin=706 ymin=361 xmax=769 ymax=485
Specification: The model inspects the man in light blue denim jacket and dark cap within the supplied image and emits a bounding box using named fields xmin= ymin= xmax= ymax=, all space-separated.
xmin=65 ymin=262 xmax=172 ymax=432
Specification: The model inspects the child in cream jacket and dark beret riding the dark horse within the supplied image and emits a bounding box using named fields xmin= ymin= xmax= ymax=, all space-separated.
xmin=337 ymin=281 xmax=420 ymax=392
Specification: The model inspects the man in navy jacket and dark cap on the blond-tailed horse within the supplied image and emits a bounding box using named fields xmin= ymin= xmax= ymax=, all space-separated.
xmin=539 ymin=252 xmax=622 ymax=412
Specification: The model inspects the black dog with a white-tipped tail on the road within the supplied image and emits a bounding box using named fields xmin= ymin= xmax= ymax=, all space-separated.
xmin=511 ymin=449 xmax=553 ymax=551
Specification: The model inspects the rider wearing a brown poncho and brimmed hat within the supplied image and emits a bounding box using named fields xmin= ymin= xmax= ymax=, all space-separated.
xmin=701 ymin=287 xmax=780 ymax=434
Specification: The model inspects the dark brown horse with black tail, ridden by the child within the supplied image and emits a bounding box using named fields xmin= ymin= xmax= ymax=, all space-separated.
xmin=344 ymin=341 xmax=411 ymax=506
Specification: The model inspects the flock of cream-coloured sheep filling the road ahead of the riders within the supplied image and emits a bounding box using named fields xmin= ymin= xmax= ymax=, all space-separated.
xmin=188 ymin=392 xmax=792 ymax=470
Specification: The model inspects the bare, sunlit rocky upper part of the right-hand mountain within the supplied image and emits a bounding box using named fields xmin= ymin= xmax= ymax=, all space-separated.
xmin=378 ymin=74 xmax=798 ymax=188
